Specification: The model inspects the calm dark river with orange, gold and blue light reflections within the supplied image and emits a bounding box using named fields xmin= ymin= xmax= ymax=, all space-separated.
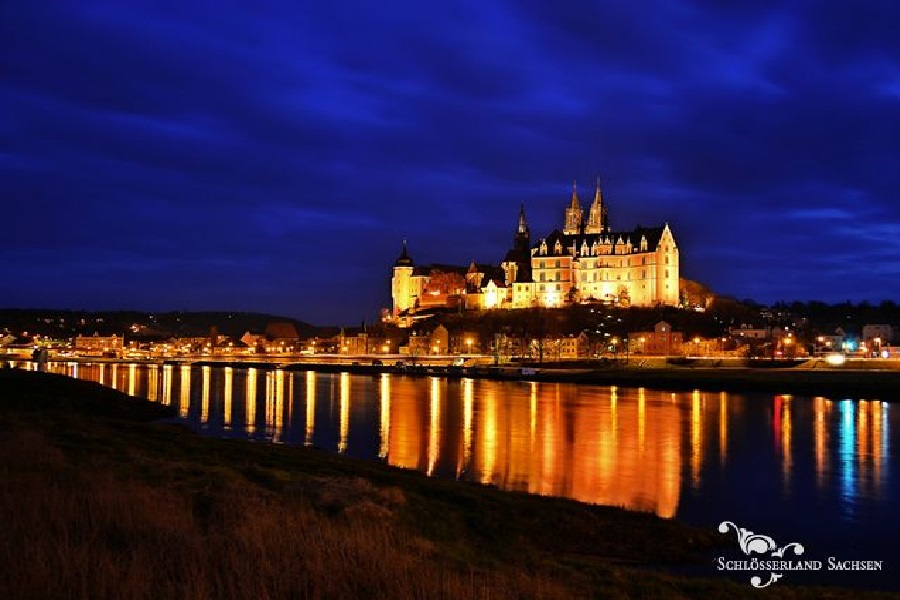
xmin=28 ymin=363 xmax=900 ymax=588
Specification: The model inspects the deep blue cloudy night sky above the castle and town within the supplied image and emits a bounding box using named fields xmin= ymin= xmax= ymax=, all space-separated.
xmin=0 ymin=0 xmax=900 ymax=325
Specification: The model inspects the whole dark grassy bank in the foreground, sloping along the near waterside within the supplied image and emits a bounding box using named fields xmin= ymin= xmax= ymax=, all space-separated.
xmin=0 ymin=370 xmax=887 ymax=599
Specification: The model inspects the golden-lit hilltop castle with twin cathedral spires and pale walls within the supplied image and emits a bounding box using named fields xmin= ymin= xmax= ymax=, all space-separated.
xmin=391 ymin=183 xmax=679 ymax=322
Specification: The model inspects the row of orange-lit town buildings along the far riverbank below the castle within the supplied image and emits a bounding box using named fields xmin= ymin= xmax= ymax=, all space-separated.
xmin=7 ymin=321 xmax=895 ymax=360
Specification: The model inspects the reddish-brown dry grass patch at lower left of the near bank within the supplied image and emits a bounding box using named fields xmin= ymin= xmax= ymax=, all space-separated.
xmin=0 ymin=432 xmax=571 ymax=599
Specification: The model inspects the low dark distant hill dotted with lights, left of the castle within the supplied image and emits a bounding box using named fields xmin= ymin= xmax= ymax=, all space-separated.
xmin=0 ymin=308 xmax=323 ymax=339
